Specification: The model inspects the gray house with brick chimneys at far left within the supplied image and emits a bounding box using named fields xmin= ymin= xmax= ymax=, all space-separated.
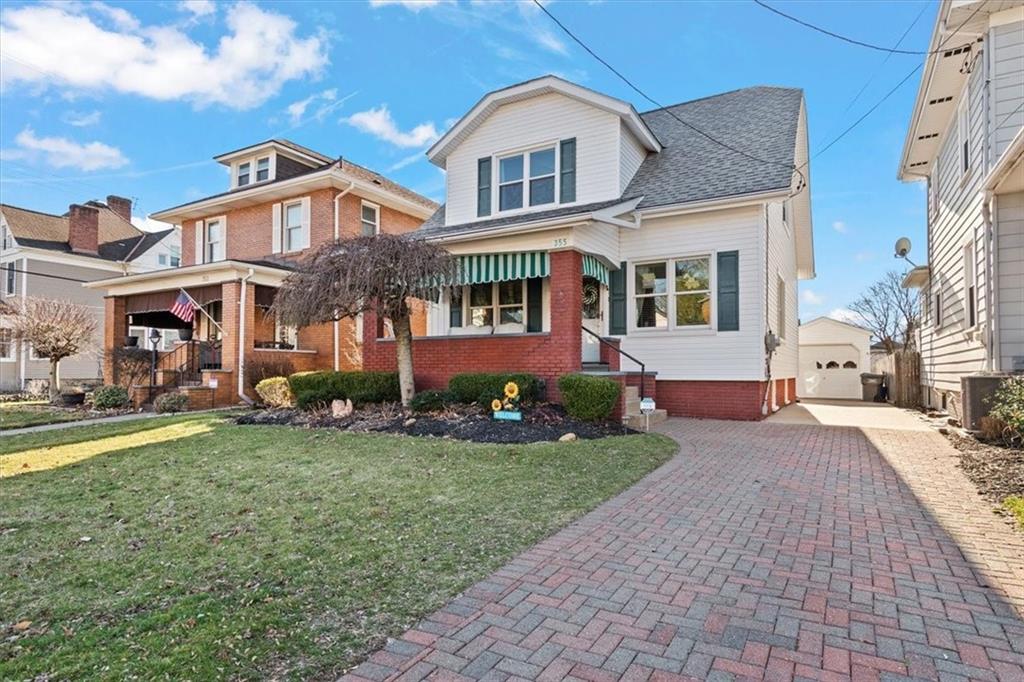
xmin=0 ymin=195 xmax=181 ymax=391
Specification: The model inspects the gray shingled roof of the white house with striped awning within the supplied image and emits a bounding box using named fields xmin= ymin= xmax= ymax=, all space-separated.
xmin=417 ymin=86 xmax=804 ymax=238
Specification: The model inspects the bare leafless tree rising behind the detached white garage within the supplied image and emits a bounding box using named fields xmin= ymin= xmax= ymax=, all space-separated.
xmin=849 ymin=270 xmax=921 ymax=355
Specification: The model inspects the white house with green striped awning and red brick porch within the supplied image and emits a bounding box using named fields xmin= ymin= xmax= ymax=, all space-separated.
xmin=364 ymin=76 xmax=814 ymax=419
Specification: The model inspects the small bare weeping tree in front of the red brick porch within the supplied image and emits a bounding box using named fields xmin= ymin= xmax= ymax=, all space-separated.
xmin=272 ymin=235 xmax=456 ymax=406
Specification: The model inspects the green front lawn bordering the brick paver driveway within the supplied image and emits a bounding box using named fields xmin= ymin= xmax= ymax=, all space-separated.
xmin=0 ymin=414 xmax=676 ymax=679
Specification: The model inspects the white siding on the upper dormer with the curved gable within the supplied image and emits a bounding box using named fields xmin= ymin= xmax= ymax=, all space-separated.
xmin=445 ymin=93 xmax=621 ymax=224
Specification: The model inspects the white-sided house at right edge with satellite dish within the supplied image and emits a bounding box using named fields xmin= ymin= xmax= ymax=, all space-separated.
xmin=899 ymin=0 xmax=1024 ymax=426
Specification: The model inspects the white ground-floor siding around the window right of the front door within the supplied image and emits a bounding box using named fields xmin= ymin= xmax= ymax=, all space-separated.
xmin=620 ymin=201 xmax=770 ymax=381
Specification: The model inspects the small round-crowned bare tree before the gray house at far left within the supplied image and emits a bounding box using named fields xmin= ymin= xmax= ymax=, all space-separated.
xmin=7 ymin=298 xmax=98 ymax=402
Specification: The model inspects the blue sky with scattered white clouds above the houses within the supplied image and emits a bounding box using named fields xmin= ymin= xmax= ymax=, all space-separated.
xmin=0 ymin=0 xmax=937 ymax=321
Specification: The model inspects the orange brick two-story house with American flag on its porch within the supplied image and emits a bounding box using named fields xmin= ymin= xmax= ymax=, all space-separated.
xmin=86 ymin=139 xmax=437 ymax=407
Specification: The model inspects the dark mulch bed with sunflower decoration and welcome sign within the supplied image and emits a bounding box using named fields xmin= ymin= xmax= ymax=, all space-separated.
xmin=236 ymin=404 xmax=638 ymax=443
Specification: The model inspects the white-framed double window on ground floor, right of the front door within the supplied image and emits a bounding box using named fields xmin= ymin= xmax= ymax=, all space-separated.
xmin=633 ymin=256 xmax=711 ymax=329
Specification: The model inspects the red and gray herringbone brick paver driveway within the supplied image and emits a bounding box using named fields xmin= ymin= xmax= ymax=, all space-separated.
xmin=350 ymin=420 xmax=1024 ymax=680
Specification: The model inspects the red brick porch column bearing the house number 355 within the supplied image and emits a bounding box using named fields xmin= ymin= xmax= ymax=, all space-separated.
xmin=548 ymin=251 xmax=583 ymax=385
